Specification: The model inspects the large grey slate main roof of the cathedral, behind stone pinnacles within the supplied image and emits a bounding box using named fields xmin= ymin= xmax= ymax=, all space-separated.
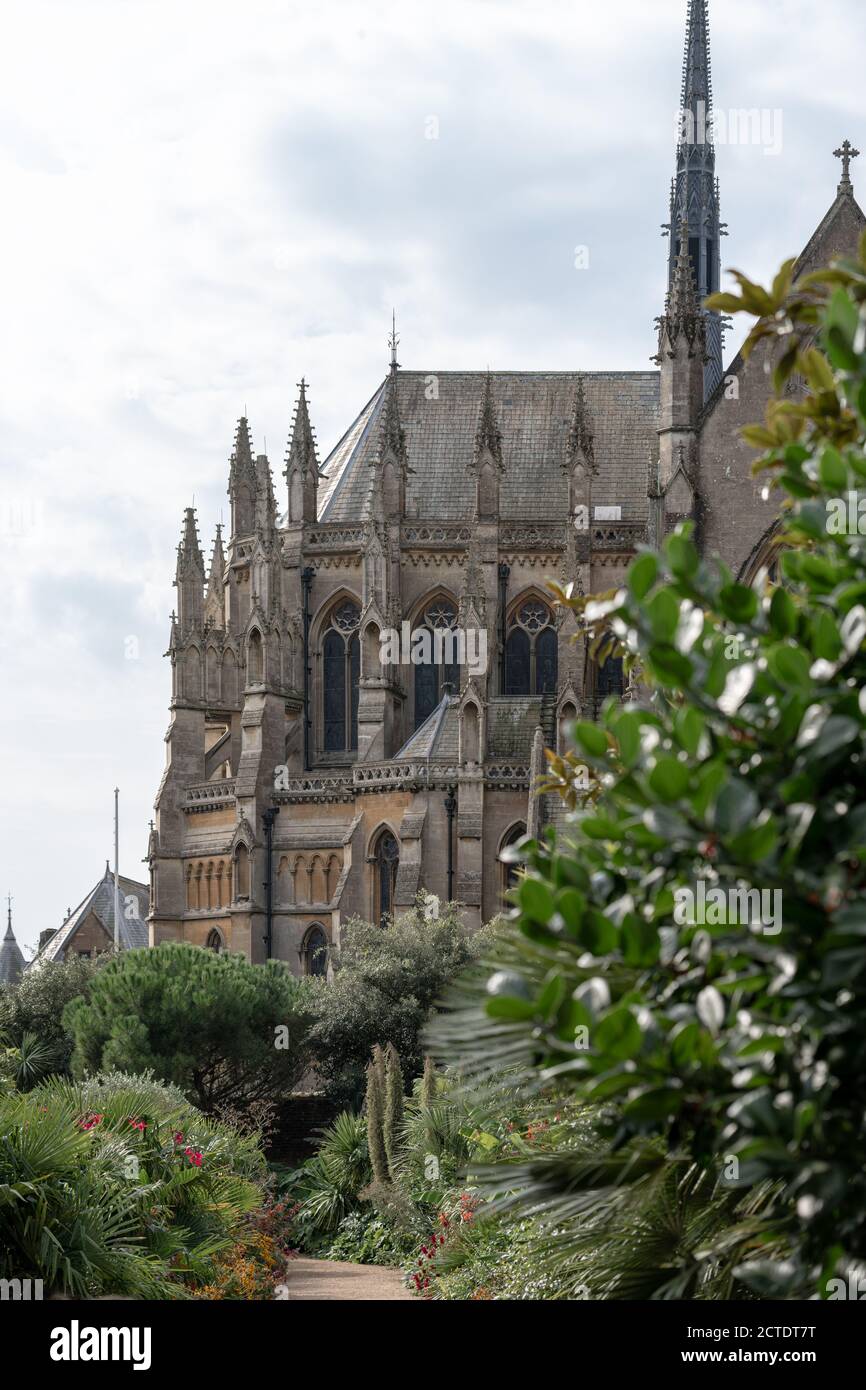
xmin=318 ymin=371 xmax=659 ymax=523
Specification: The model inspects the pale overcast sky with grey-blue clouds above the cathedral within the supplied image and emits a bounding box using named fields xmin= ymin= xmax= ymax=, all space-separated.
xmin=0 ymin=0 xmax=866 ymax=947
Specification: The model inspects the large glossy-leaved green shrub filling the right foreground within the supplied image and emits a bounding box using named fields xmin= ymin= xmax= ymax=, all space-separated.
xmin=432 ymin=236 xmax=866 ymax=1298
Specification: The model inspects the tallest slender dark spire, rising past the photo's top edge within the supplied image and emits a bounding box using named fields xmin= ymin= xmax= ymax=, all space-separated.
xmin=664 ymin=0 xmax=723 ymax=399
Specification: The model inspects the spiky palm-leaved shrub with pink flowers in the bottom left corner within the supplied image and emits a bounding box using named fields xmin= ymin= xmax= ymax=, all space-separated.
xmin=0 ymin=1074 xmax=267 ymax=1298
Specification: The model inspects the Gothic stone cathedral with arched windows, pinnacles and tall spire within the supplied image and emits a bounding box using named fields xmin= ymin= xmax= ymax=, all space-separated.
xmin=149 ymin=0 xmax=865 ymax=973
